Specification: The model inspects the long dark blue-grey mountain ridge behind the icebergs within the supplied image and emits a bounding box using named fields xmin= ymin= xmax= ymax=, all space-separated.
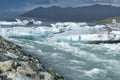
xmin=20 ymin=5 xmax=120 ymax=22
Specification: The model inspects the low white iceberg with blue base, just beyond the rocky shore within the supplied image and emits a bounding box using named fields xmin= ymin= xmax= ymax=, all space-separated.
xmin=0 ymin=26 xmax=51 ymax=40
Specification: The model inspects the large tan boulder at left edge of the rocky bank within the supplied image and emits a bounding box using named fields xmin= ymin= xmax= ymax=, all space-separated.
xmin=0 ymin=61 xmax=13 ymax=72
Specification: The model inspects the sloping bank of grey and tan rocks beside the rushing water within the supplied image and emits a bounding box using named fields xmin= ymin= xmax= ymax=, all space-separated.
xmin=0 ymin=37 xmax=63 ymax=80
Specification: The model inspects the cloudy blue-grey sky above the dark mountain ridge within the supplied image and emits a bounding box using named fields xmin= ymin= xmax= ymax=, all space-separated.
xmin=0 ymin=0 xmax=120 ymax=18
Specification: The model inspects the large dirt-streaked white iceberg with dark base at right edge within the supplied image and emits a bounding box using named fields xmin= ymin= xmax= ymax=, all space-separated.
xmin=54 ymin=22 xmax=120 ymax=43
